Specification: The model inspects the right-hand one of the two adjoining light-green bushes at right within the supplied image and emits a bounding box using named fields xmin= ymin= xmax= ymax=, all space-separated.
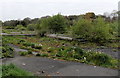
xmin=91 ymin=18 xmax=113 ymax=42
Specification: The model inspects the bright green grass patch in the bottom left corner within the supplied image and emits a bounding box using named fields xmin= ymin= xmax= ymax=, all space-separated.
xmin=2 ymin=64 xmax=33 ymax=78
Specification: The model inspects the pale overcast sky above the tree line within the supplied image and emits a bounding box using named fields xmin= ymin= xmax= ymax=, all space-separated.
xmin=0 ymin=0 xmax=119 ymax=21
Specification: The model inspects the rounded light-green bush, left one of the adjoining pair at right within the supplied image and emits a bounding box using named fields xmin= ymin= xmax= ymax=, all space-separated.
xmin=71 ymin=19 xmax=93 ymax=39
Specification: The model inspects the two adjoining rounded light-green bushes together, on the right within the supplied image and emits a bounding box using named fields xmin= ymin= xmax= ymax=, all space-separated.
xmin=71 ymin=17 xmax=114 ymax=43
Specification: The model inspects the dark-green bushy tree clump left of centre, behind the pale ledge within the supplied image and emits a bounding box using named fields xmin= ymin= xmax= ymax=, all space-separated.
xmin=37 ymin=14 xmax=66 ymax=34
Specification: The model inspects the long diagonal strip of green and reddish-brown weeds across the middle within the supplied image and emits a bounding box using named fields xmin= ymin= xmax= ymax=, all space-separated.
xmin=2 ymin=36 xmax=118 ymax=68
